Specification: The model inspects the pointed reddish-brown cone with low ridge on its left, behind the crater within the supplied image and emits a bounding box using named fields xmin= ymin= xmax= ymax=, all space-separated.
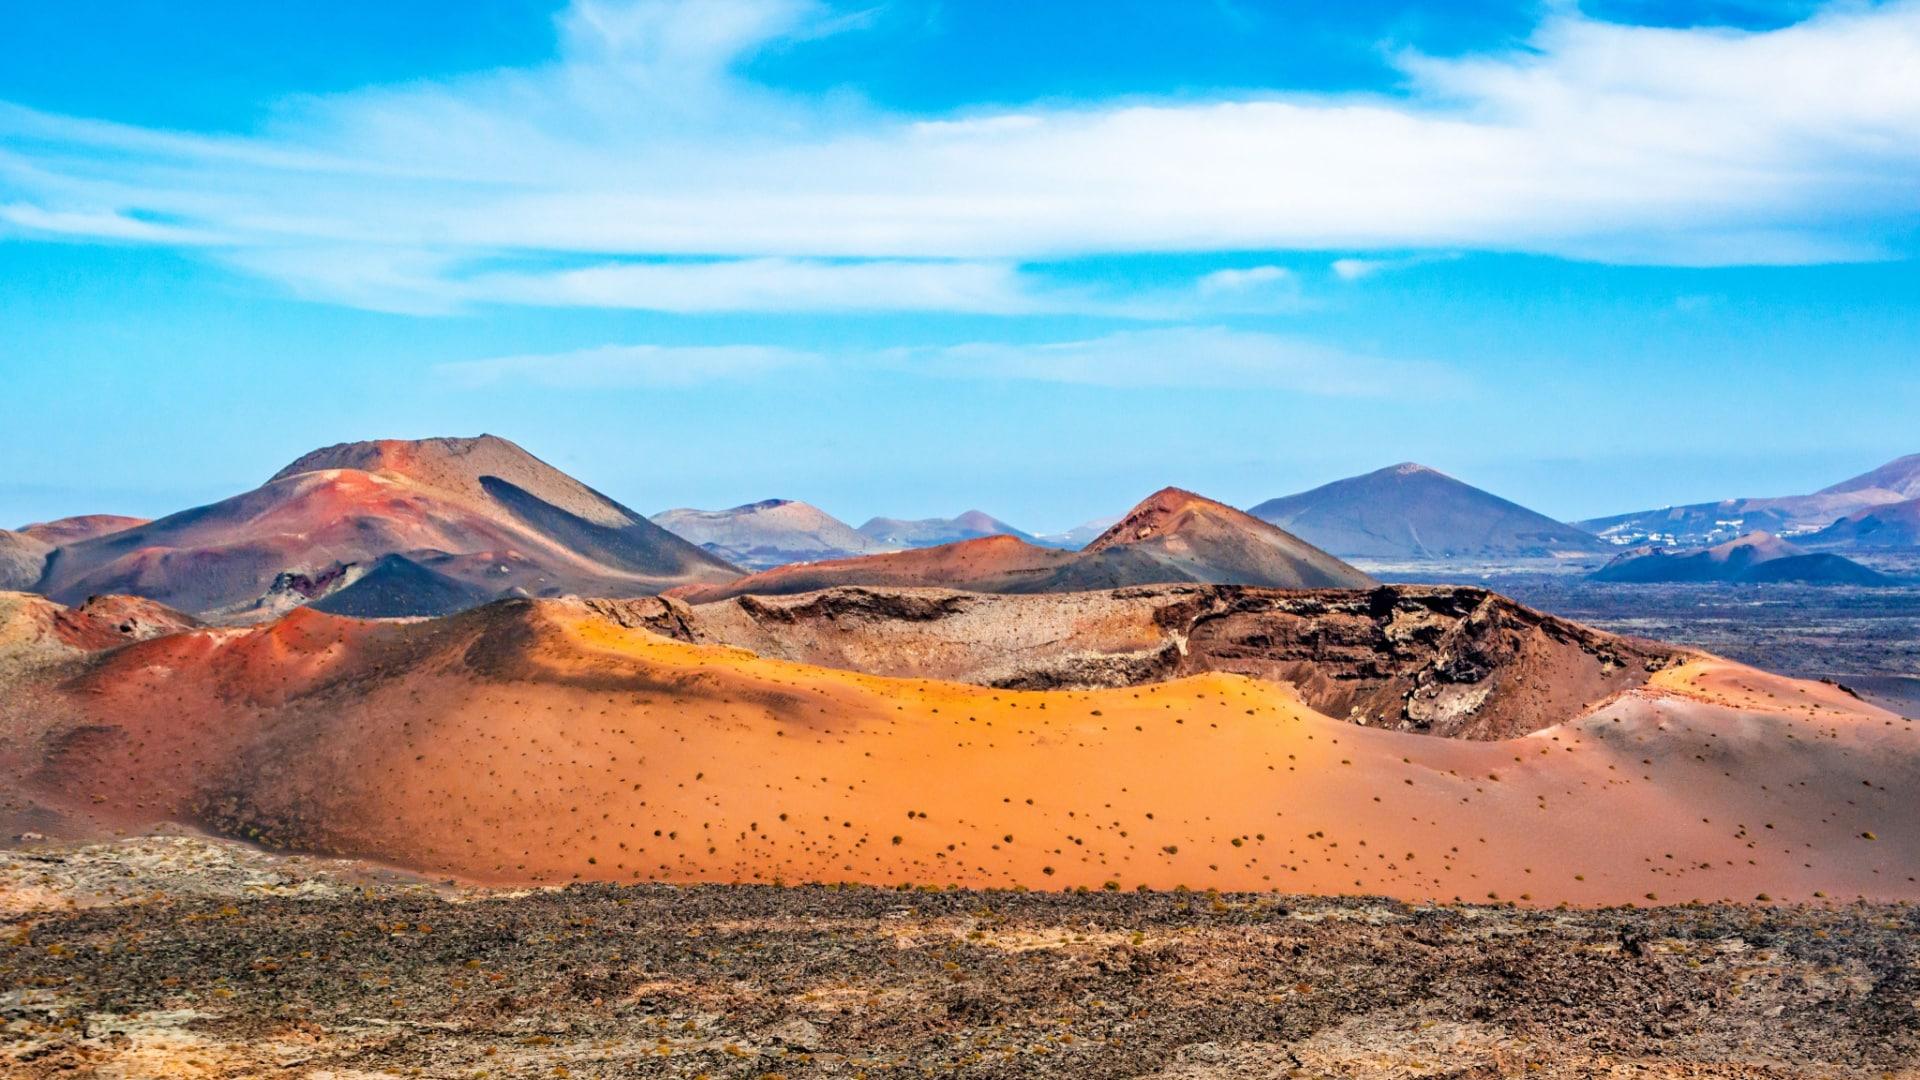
xmin=672 ymin=488 xmax=1377 ymax=603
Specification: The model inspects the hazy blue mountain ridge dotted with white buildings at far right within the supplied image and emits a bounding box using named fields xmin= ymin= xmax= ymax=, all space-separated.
xmin=1578 ymin=454 xmax=1920 ymax=548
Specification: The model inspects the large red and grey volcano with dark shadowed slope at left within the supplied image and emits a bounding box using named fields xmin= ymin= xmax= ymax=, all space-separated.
xmin=40 ymin=434 xmax=737 ymax=613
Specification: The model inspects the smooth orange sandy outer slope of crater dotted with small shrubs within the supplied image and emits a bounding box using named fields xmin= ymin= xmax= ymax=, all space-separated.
xmin=18 ymin=601 xmax=1920 ymax=903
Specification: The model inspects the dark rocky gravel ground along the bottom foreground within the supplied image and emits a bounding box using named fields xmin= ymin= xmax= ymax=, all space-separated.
xmin=0 ymin=838 xmax=1920 ymax=1080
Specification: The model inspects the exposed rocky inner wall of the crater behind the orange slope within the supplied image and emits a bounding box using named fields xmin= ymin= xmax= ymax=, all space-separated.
xmin=588 ymin=586 xmax=1684 ymax=740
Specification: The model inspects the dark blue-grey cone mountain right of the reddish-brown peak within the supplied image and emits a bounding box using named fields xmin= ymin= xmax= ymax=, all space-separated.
xmin=1248 ymin=461 xmax=1605 ymax=559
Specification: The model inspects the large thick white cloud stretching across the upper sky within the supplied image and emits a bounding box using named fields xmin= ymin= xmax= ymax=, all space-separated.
xmin=0 ymin=0 xmax=1920 ymax=313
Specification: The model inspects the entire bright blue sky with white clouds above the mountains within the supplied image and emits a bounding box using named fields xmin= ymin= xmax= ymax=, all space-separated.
xmin=0 ymin=0 xmax=1920 ymax=530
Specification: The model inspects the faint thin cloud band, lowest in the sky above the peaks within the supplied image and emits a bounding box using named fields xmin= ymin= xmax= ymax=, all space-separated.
xmin=436 ymin=327 xmax=1465 ymax=398
